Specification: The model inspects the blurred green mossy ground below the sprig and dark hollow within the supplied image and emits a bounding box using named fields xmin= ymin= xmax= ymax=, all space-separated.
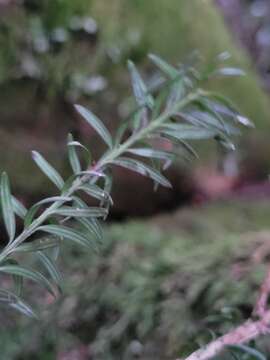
xmin=0 ymin=202 xmax=270 ymax=360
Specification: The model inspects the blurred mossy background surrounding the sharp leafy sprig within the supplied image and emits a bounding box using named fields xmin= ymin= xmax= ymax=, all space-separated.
xmin=0 ymin=0 xmax=270 ymax=360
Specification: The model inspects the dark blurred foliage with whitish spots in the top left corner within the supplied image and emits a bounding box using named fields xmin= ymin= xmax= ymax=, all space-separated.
xmin=0 ymin=0 xmax=98 ymax=100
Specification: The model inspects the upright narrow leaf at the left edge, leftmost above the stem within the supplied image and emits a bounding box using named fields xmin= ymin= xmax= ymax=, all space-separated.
xmin=0 ymin=172 xmax=16 ymax=243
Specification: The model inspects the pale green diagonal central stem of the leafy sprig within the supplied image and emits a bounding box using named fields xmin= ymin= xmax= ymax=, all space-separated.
xmin=0 ymin=90 xmax=198 ymax=263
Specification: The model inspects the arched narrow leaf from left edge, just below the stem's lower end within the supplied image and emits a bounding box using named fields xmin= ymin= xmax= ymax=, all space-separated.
xmin=0 ymin=265 xmax=56 ymax=296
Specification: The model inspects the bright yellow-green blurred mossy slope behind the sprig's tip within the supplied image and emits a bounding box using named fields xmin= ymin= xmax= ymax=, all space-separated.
xmin=92 ymin=0 xmax=270 ymax=129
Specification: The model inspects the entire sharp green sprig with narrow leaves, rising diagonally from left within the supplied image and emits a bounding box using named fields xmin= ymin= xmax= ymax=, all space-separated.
xmin=0 ymin=55 xmax=251 ymax=316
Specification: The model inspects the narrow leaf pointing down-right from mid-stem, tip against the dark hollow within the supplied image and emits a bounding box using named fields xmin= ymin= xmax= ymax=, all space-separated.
xmin=112 ymin=157 xmax=172 ymax=188
